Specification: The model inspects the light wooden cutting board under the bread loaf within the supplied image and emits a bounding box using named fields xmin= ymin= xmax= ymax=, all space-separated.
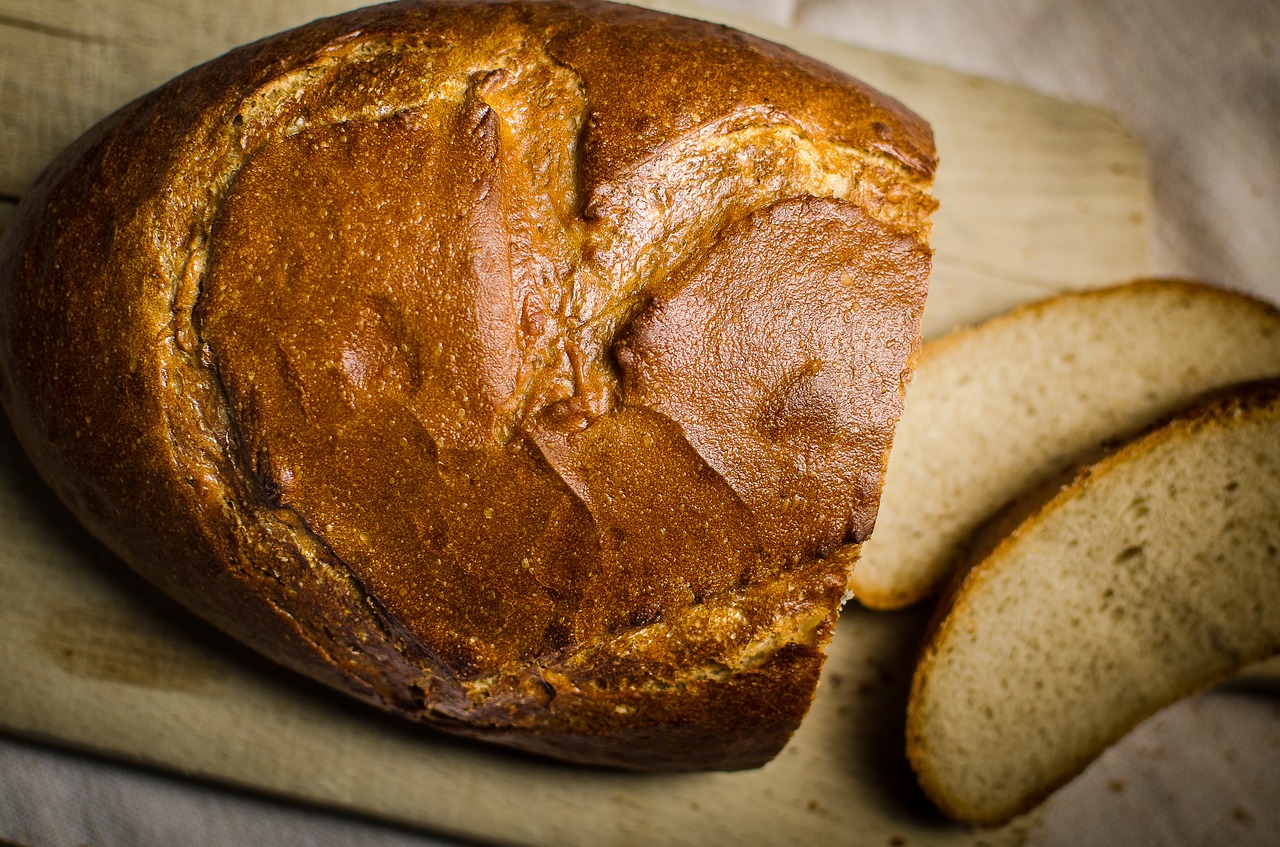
xmin=0 ymin=0 xmax=1148 ymax=847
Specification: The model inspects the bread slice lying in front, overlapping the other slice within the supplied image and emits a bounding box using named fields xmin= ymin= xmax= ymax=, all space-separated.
xmin=908 ymin=380 xmax=1280 ymax=824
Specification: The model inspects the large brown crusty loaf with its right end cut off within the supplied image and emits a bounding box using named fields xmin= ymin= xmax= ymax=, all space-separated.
xmin=0 ymin=0 xmax=934 ymax=769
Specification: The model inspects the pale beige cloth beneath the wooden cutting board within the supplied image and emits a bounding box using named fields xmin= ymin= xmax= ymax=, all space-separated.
xmin=0 ymin=0 xmax=1280 ymax=847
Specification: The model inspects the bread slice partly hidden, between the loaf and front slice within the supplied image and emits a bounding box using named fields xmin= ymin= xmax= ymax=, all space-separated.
xmin=850 ymin=280 xmax=1280 ymax=609
